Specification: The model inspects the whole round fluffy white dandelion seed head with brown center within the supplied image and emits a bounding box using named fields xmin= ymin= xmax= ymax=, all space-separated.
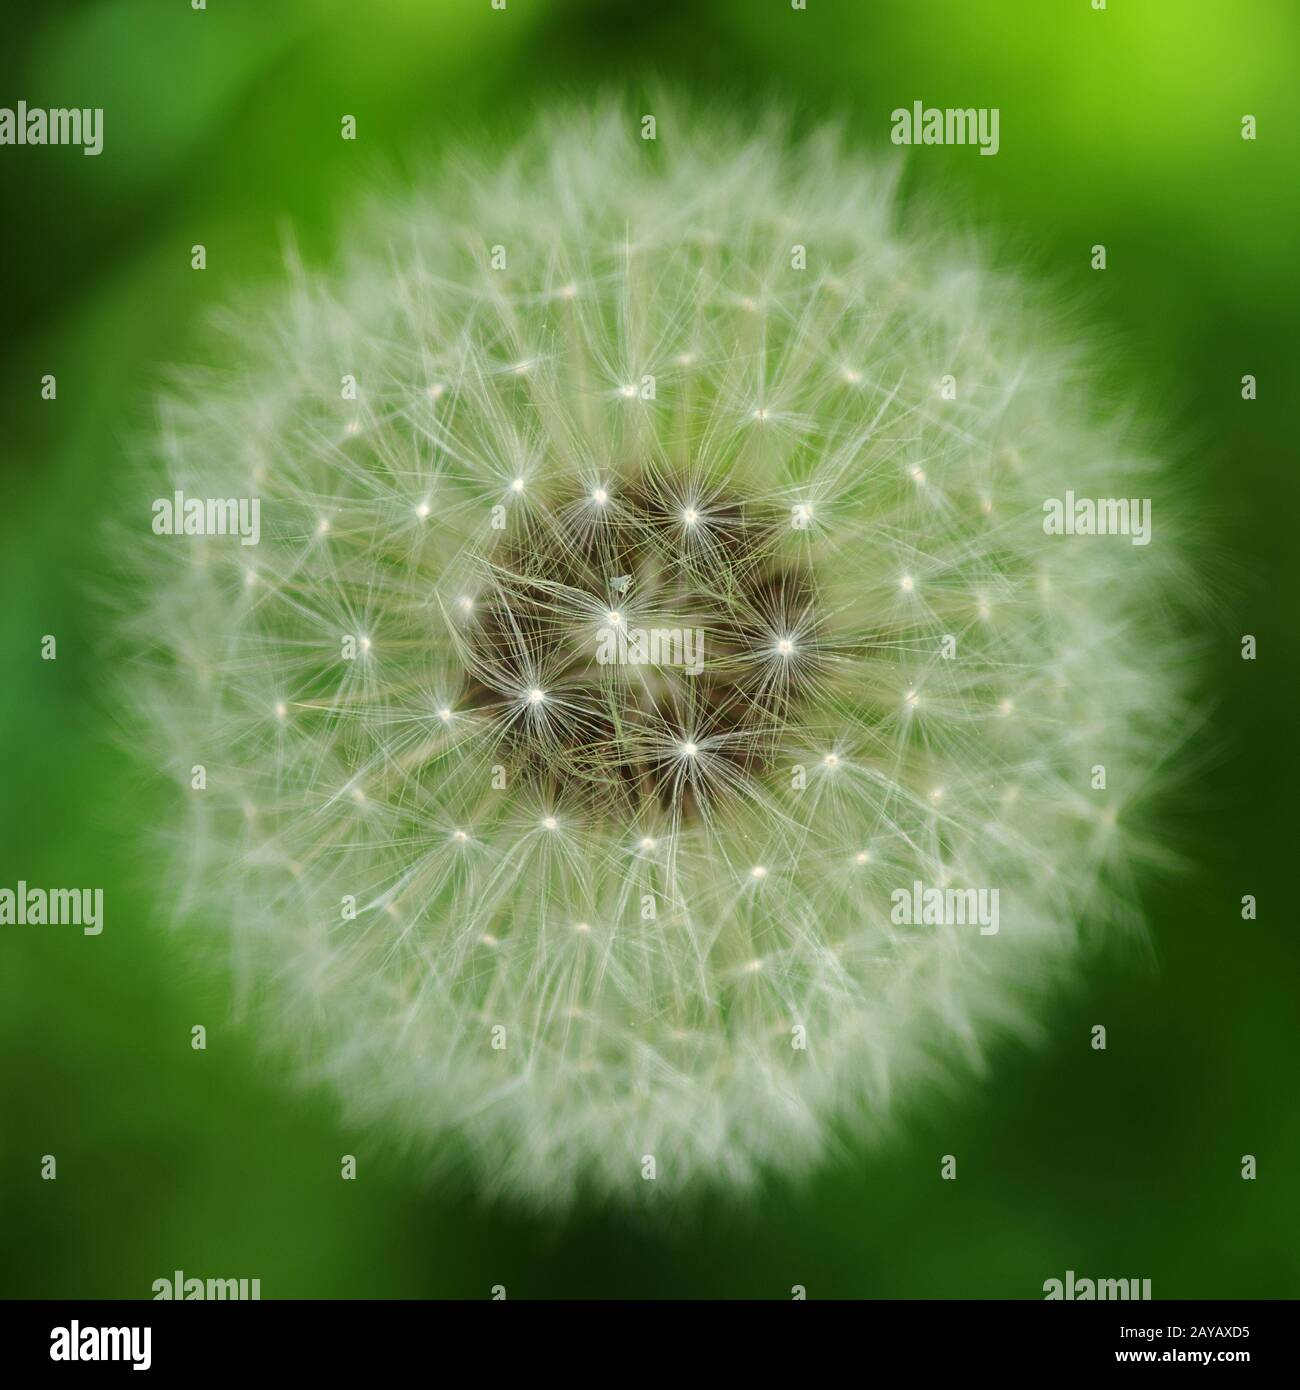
xmin=119 ymin=102 xmax=1183 ymax=1202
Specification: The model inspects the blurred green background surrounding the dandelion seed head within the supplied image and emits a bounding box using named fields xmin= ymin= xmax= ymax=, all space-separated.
xmin=0 ymin=0 xmax=1300 ymax=1298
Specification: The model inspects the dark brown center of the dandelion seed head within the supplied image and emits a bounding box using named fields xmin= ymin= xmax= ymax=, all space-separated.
xmin=466 ymin=473 xmax=824 ymax=816
